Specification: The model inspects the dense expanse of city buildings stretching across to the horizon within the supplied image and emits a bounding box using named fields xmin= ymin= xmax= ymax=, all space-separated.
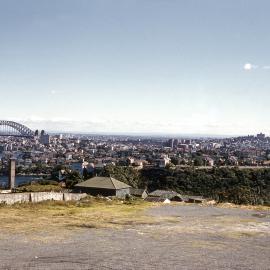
xmin=0 ymin=133 xmax=270 ymax=177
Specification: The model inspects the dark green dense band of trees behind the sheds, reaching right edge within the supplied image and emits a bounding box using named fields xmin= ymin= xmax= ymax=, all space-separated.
xmin=102 ymin=166 xmax=270 ymax=205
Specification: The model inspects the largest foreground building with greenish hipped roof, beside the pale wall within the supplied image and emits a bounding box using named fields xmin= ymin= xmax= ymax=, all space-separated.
xmin=74 ymin=176 xmax=131 ymax=198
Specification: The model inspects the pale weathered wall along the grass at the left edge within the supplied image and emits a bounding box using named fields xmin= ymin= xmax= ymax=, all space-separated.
xmin=0 ymin=192 xmax=87 ymax=204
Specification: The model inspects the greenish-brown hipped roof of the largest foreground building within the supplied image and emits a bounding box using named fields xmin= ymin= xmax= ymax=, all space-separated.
xmin=75 ymin=176 xmax=130 ymax=190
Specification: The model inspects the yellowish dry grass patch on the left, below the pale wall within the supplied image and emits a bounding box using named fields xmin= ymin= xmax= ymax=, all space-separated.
xmin=0 ymin=198 xmax=158 ymax=233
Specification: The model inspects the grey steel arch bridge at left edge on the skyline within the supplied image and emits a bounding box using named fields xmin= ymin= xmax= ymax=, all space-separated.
xmin=0 ymin=120 xmax=35 ymax=138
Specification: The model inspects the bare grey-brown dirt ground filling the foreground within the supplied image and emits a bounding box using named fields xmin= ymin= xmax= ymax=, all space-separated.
xmin=0 ymin=205 xmax=270 ymax=270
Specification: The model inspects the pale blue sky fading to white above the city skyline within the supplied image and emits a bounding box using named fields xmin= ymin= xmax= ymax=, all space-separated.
xmin=0 ymin=0 xmax=270 ymax=135
